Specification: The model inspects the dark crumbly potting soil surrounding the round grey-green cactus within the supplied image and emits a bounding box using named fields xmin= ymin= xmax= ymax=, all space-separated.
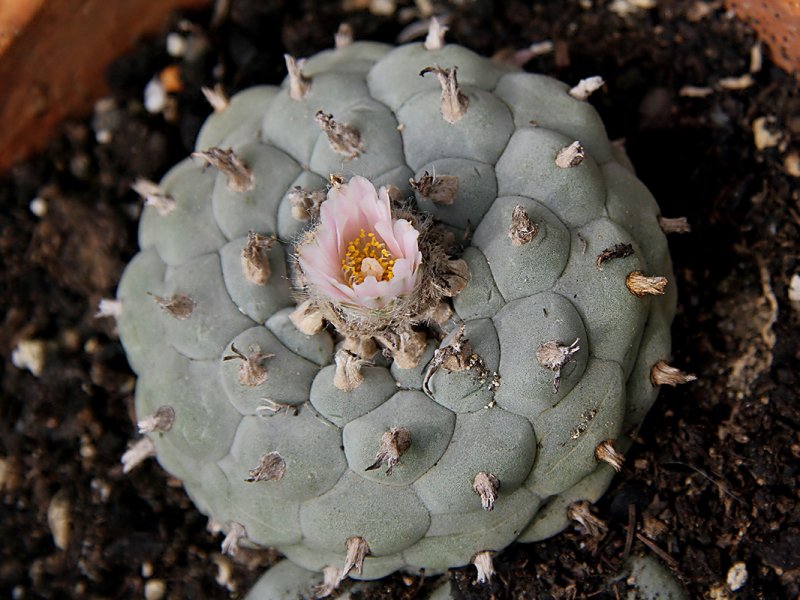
xmin=0 ymin=0 xmax=800 ymax=599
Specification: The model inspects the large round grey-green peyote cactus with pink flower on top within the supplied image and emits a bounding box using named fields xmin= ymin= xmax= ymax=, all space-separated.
xmin=118 ymin=22 xmax=687 ymax=595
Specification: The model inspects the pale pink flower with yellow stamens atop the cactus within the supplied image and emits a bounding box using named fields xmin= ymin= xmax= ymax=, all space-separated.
xmin=297 ymin=176 xmax=422 ymax=309
